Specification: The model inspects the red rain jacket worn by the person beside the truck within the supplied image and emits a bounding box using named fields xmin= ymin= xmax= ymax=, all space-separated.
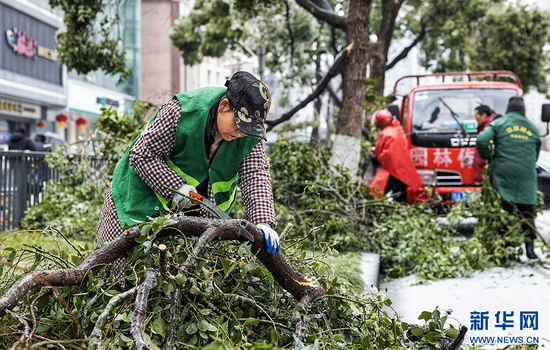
xmin=371 ymin=119 xmax=424 ymax=193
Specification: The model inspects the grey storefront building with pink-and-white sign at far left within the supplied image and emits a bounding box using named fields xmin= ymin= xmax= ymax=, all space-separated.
xmin=0 ymin=0 xmax=67 ymax=147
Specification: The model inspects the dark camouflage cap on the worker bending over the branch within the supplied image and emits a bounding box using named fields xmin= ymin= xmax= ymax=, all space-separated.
xmin=225 ymin=71 xmax=271 ymax=140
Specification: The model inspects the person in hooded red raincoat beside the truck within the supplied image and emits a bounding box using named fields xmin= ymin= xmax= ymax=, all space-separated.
xmin=370 ymin=110 xmax=424 ymax=202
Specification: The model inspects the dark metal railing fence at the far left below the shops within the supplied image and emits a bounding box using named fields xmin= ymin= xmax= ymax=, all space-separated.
xmin=0 ymin=151 xmax=105 ymax=231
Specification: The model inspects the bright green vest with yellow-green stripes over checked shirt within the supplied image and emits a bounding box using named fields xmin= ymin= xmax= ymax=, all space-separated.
xmin=112 ymin=87 xmax=258 ymax=227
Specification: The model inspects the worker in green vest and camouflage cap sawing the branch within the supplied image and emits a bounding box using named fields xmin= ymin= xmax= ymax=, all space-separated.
xmin=97 ymin=71 xmax=279 ymax=254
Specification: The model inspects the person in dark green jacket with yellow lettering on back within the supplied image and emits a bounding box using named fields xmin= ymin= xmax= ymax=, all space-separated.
xmin=476 ymin=96 xmax=541 ymax=259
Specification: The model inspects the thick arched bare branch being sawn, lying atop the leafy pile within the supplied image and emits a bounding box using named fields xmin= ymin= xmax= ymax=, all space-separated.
xmin=0 ymin=215 xmax=323 ymax=315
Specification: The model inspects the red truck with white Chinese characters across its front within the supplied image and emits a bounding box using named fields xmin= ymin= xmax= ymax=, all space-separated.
xmin=388 ymin=71 xmax=523 ymax=204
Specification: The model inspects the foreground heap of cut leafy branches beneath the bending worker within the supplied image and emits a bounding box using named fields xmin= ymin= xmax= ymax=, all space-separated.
xmin=0 ymin=212 xmax=470 ymax=350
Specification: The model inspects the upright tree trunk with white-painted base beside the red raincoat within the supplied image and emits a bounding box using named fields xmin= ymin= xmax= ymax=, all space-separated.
xmin=330 ymin=0 xmax=372 ymax=175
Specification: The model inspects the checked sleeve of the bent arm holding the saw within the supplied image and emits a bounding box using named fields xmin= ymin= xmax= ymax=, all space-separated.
xmin=129 ymin=100 xmax=185 ymax=201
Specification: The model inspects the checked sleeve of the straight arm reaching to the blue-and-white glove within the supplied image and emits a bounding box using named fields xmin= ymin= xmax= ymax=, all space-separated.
xmin=238 ymin=140 xmax=277 ymax=229
